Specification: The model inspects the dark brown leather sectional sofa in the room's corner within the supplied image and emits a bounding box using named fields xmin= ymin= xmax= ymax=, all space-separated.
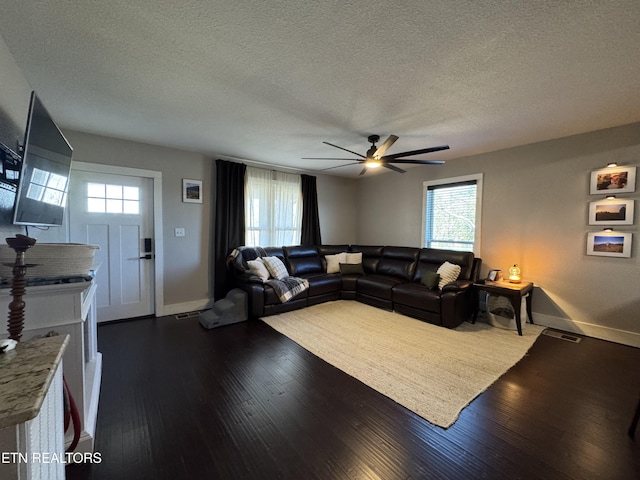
xmin=233 ymin=245 xmax=481 ymax=328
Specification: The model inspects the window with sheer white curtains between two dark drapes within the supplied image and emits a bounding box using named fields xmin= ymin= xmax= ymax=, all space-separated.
xmin=245 ymin=167 xmax=302 ymax=247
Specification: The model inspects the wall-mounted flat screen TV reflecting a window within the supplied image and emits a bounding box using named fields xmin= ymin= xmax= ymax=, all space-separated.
xmin=13 ymin=92 xmax=73 ymax=226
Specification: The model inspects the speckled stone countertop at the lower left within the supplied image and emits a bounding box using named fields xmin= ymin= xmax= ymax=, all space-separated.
xmin=0 ymin=335 xmax=69 ymax=429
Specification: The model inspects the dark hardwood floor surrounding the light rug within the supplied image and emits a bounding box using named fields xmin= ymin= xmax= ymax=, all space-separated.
xmin=67 ymin=310 xmax=640 ymax=480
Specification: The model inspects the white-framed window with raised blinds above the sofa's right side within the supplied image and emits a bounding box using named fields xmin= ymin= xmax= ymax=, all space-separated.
xmin=422 ymin=174 xmax=482 ymax=255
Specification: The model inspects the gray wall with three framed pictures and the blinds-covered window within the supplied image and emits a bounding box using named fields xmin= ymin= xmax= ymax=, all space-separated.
xmin=357 ymin=124 xmax=640 ymax=346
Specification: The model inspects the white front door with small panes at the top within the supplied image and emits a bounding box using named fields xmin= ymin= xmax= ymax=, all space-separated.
xmin=68 ymin=169 xmax=155 ymax=322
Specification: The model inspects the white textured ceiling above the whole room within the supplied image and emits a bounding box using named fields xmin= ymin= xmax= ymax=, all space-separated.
xmin=0 ymin=0 xmax=640 ymax=175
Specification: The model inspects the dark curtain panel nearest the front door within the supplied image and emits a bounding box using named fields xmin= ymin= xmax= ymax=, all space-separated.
xmin=213 ymin=160 xmax=247 ymax=300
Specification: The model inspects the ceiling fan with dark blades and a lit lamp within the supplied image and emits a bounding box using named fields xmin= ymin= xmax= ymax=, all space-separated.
xmin=303 ymin=135 xmax=449 ymax=175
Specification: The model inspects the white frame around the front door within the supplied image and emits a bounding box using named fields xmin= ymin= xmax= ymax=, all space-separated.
xmin=67 ymin=161 xmax=164 ymax=317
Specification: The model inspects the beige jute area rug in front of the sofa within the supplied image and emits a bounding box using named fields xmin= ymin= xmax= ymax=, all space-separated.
xmin=262 ymin=300 xmax=544 ymax=428
